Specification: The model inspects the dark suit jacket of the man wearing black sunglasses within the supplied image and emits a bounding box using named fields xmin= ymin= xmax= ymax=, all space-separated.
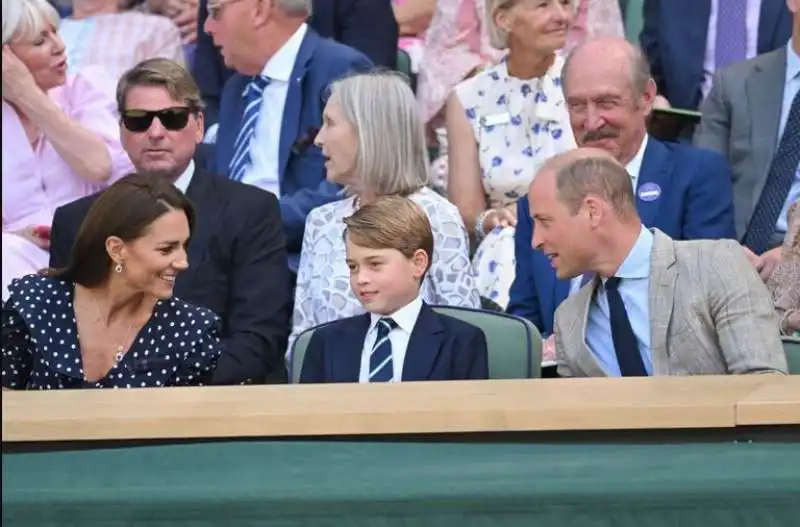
xmin=50 ymin=165 xmax=292 ymax=384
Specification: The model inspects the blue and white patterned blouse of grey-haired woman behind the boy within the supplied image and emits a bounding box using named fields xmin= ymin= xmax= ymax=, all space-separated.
xmin=287 ymin=188 xmax=481 ymax=357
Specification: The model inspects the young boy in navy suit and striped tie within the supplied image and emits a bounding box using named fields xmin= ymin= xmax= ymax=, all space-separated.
xmin=300 ymin=196 xmax=488 ymax=383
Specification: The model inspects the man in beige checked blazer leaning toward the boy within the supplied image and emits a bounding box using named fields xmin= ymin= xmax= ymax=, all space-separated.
xmin=528 ymin=148 xmax=787 ymax=377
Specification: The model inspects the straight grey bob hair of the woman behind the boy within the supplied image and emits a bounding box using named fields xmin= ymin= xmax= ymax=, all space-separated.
xmin=329 ymin=71 xmax=428 ymax=196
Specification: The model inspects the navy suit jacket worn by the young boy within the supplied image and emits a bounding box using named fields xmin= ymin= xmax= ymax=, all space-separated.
xmin=300 ymin=303 xmax=489 ymax=383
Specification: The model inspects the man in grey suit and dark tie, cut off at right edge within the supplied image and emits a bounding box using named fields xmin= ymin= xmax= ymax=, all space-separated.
xmin=694 ymin=0 xmax=800 ymax=279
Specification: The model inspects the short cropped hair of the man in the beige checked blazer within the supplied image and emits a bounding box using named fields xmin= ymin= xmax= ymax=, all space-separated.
xmin=555 ymin=156 xmax=636 ymax=218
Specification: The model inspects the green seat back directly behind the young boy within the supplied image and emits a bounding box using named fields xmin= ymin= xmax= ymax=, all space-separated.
xmin=289 ymin=306 xmax=542 ymax=383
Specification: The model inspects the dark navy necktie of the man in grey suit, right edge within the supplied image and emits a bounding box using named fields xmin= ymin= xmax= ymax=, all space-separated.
xmin=742 ymin=92 xmax=800 ymax=254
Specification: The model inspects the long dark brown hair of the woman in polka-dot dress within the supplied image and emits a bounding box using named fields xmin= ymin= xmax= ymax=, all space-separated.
xmin=46 ymin=174 xmax=195 ymax=287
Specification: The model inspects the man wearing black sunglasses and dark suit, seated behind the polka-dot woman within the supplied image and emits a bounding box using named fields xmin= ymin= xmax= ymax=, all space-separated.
xmin=50 ymin=59 xmax=291 ymax=384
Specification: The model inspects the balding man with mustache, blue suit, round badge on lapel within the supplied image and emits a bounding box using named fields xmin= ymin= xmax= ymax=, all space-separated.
xmin=507 ymin=37 xmax=736 ymax=359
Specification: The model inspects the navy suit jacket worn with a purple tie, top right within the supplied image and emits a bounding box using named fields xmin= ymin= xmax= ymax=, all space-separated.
xmin=639 ymin=0 xmax=792 ymax=109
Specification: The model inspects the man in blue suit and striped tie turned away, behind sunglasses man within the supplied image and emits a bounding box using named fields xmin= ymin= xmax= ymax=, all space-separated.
xmin=205 ymin=0 xmax=371 ymax=268
